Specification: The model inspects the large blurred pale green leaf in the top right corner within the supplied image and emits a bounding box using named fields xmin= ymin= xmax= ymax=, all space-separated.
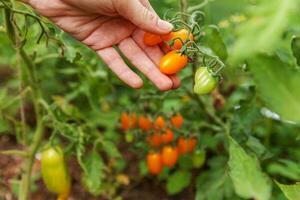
xmin=231 ymin=0 xmax=299 ymax=62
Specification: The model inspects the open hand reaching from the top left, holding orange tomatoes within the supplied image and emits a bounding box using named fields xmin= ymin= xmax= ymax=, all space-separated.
xmin=23 ymin=0 xmax=180 ymax=91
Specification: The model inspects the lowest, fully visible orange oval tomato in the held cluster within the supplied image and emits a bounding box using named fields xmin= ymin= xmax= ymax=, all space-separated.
xmin=159 ymin=50 xmax=188 ymax=75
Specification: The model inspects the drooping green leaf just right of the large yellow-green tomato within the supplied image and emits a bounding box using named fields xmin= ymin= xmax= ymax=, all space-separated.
xmin=82 ymin=151 xmax=104 ymax=196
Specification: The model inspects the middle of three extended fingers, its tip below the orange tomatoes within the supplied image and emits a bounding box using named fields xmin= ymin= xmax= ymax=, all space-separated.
xmin=119 ymin=38 xmax=173 ymax=90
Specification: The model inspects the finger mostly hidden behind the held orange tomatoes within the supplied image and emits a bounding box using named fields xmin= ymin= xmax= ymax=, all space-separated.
xmin=132 ymin=30 xmax=180 ymax=89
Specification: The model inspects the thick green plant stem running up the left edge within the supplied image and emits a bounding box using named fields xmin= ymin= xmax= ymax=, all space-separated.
xmin=4 ymin=5 xmax=44 ymax=200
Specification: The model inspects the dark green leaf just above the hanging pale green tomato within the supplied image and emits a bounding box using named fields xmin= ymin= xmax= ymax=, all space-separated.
xmin=203 ymin=26 xmax=228 ymax=61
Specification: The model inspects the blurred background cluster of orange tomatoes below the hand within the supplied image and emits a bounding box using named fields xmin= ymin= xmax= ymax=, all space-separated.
xmin=121 ymin=112 xmax=202 ymax=175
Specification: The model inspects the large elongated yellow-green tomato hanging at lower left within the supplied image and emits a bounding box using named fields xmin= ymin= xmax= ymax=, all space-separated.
xmin=41 ymin=146 xmax=71 ymax=197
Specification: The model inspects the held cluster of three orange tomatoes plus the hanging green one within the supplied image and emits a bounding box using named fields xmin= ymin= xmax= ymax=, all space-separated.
xmin=144 ymin=28 xmax=218 ymax=95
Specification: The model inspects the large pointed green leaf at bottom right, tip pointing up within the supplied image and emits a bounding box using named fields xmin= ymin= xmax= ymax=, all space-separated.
xmin=228 ymin=137 xmax=272 ymax=200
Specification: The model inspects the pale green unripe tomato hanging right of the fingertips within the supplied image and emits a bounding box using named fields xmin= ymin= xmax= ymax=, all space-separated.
xmin=194 ymin=67 xmax=218 ymax=95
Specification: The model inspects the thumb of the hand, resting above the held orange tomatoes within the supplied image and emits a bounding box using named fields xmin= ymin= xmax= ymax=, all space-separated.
xmin=116 ymin=0 xmax=173 ymax=34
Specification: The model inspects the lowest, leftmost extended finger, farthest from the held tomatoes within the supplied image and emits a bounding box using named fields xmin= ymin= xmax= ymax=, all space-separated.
xmin=97 ymin=47 xmax=143 ymax=88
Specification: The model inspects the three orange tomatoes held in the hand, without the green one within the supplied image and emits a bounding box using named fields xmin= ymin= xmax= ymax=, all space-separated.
xmin=144 ymin=28 xmax=194 ymax=75
